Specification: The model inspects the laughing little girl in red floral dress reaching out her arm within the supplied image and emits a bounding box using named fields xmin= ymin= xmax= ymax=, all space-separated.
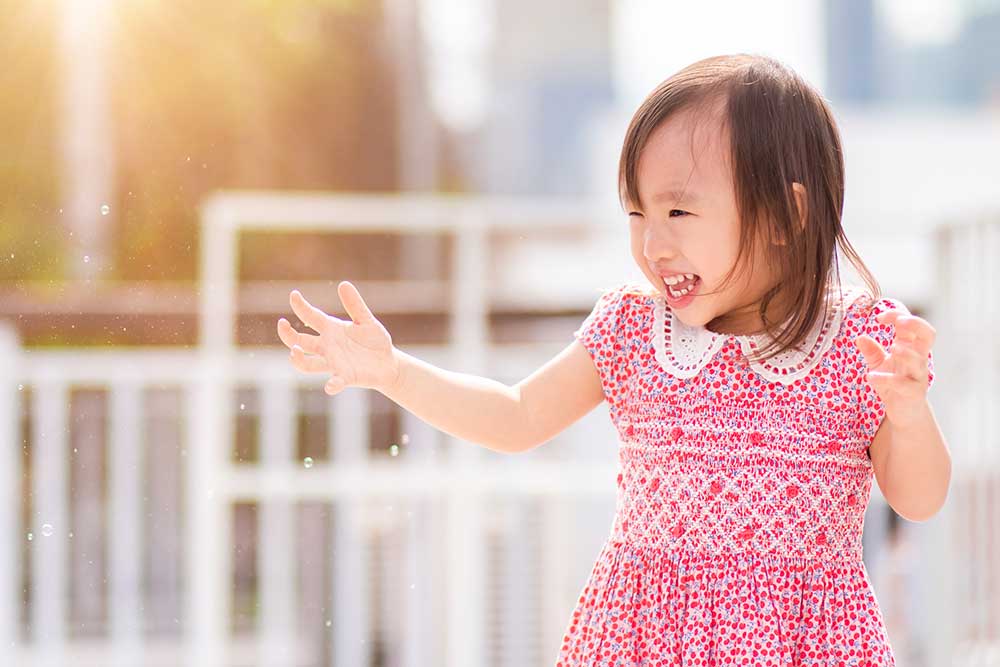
xmin=278 ymin=55 xmax=951 ymax=667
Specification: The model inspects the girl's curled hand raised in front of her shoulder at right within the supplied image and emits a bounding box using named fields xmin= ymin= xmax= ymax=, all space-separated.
xmin=854 ymin=309 xmax=937 ymax=423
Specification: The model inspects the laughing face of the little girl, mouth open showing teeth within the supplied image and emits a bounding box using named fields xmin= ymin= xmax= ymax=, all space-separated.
xmin=627 ymin=109 xmax=776 ymax=333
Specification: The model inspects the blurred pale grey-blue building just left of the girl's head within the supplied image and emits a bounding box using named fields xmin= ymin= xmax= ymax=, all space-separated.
xmin=461 ymin=0 xmax=614 ymax=195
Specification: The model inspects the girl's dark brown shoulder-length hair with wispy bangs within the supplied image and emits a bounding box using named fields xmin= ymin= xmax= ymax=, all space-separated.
xmin=618 ymin=54 xmax=881 ymax=366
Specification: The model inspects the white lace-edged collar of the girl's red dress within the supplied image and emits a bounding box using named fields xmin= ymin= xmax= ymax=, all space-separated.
xmin=653 ymin=286 xmax=858 ymax=384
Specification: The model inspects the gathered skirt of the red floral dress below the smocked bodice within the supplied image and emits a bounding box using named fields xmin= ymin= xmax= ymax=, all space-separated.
xmin=556 ymin=542 xmax=895 ymax=667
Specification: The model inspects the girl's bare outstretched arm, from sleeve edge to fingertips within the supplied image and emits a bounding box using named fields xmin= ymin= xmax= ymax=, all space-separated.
xmin=278 ymin=281 xmax=604 ymax=453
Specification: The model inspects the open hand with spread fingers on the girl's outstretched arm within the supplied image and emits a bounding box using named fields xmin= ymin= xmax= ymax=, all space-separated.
xmin=278 ymin=280 xmax=399 ymax=396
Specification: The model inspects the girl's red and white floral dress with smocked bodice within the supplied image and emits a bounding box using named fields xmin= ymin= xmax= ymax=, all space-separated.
xmin=556 ymin=284 xmax=934 ymax=667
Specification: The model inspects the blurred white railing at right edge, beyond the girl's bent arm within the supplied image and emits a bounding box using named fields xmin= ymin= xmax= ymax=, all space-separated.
xmin=921 ymin=215 xmax=1000 ymax=667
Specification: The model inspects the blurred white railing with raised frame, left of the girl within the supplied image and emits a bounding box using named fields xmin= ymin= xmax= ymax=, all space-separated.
xmin=0 ymin=195 xmax=616 ymax=666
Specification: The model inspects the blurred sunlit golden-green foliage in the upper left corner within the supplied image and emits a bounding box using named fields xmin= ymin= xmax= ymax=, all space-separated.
xmin=0 ymin=0 xmax=396 ymax=280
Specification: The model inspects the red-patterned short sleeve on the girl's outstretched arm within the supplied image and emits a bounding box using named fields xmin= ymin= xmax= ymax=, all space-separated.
xmin=573 ymin=285 xmax=626 ymax=408
